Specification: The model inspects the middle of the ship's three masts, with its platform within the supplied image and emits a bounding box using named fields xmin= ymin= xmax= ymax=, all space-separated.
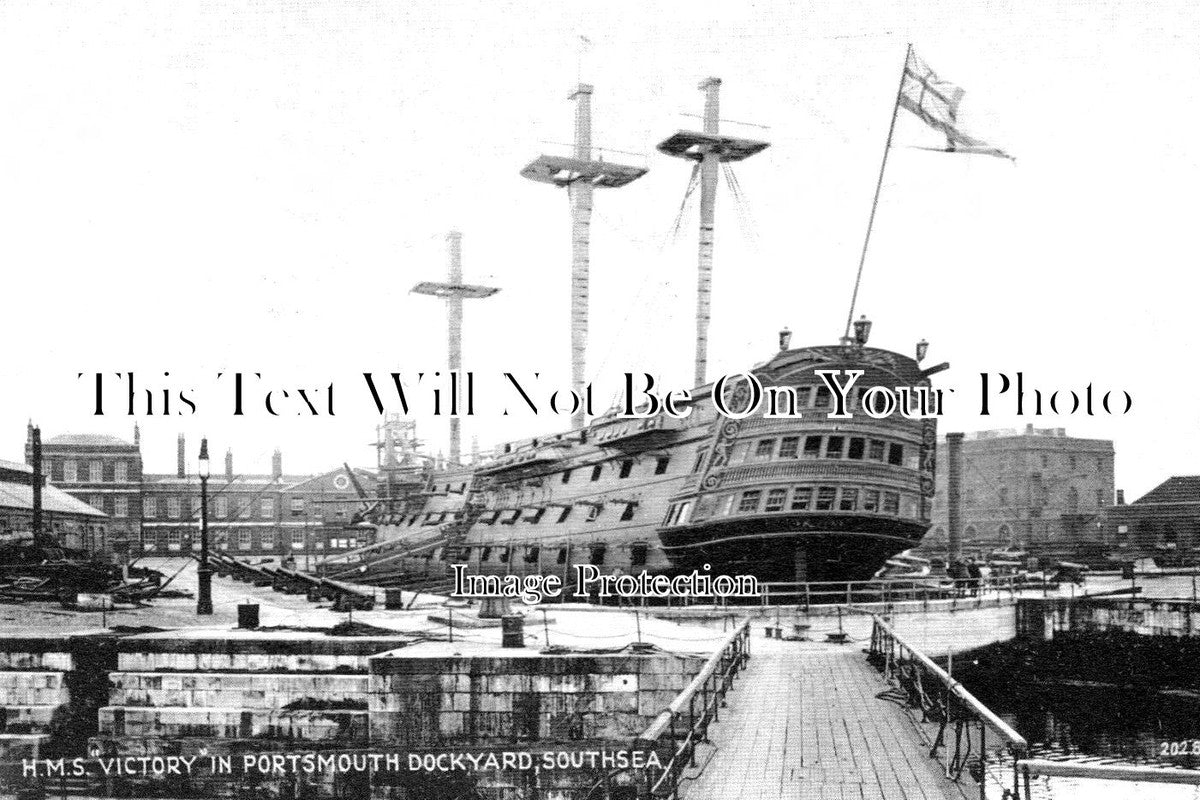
xmin=521 ymin=83 xmax=647 ymax=428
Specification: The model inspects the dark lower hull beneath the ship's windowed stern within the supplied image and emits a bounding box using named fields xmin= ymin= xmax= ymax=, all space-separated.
xmin=659 ymin=515 xmax=926 ymax=583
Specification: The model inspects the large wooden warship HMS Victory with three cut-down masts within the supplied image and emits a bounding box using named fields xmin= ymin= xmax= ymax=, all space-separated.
xmin=318 ymin=78 xmax=947 ymax=591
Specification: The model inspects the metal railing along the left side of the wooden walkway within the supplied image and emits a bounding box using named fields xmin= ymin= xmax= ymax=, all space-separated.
xmin=635 ymin=619 xmax=750 ymax=799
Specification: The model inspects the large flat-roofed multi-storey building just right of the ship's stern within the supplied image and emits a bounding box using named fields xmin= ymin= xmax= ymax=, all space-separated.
xmin=919 ymin=425 xmax=1114 ymax=560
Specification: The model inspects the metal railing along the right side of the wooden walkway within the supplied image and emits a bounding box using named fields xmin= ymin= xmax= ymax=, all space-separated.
xmin=868 ymin=614 xmax=1028 ymax=800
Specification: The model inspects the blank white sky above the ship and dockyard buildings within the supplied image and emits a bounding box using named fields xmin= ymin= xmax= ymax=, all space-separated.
xmin=0 ymin=0 xmax=1200 ymax=498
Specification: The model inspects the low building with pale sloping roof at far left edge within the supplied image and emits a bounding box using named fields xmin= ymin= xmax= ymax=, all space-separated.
xmin=0 ymin=461 xmax=109 ymax=549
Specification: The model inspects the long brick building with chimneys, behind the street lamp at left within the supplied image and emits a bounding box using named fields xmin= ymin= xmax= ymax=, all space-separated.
xmin=26 ymin=428 xmax=376 ymax=566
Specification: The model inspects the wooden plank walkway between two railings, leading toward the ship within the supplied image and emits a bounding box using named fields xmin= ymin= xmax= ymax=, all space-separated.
xmin=682 ymin=638 xmax=978 ymax=800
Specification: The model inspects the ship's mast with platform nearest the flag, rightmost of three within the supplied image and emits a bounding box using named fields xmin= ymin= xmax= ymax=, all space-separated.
xmin=659 ymin=78 xmax=769 ymax=386
